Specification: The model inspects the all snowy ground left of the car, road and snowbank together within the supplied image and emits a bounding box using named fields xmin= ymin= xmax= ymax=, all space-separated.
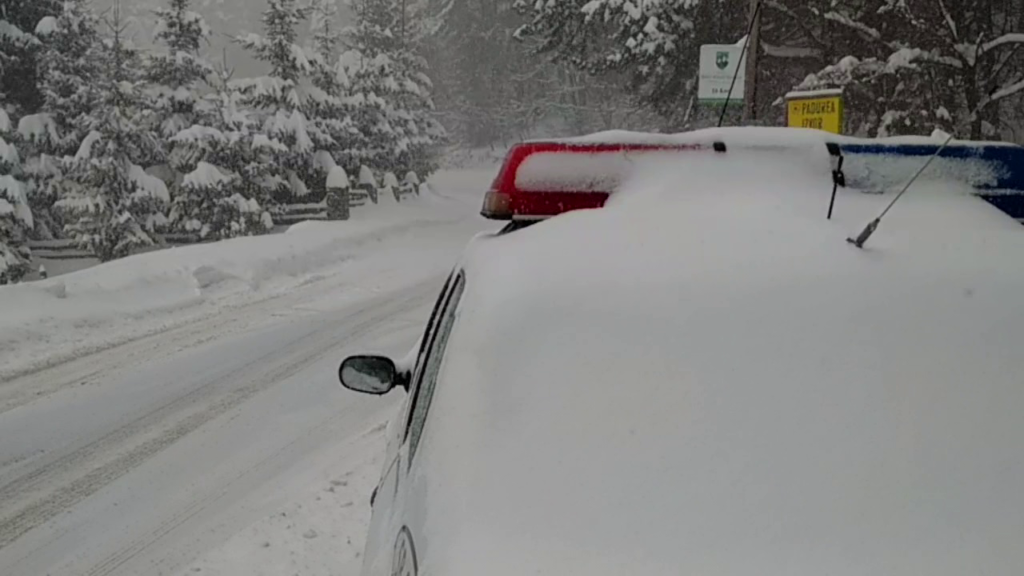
xmin=0 ymin=167 xmax=496 ymax=576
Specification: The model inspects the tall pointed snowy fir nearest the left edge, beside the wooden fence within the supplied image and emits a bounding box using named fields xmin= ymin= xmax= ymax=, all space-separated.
xmin=56 ymin=3 xmax=170 ymax=261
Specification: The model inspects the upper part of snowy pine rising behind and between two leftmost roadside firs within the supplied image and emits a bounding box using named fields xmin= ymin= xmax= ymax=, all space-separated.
xmin=146 ymin=0 xmax=213 ymax=155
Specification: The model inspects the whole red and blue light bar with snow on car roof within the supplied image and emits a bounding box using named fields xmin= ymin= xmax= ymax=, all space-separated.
xmin=501 ymin=128 xmax=1024 ymax=221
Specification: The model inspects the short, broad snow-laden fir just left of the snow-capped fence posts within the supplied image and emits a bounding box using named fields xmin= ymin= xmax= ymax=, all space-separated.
xmin=170 ymin=63 xmax=284 ymax=240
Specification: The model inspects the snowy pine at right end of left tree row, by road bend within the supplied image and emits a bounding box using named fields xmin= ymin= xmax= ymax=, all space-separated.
xmin=344 ymin=0 xmax=445 ymax=175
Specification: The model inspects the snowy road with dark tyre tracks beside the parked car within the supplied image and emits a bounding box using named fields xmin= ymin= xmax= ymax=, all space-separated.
xmin=0 ymin=170 xmax=494 ymax=576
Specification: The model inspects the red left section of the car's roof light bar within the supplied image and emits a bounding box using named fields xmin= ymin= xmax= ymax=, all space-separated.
xmin=481 ymin=142 xmax=724 ymax=220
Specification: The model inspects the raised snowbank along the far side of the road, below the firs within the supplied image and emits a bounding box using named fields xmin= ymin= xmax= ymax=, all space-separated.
xmin=0 ymin=184 xmax=471 ymax=379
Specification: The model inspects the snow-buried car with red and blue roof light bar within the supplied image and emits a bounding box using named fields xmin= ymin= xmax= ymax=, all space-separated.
xmin=340 ymin=130 xmax=1024 ymax=576
